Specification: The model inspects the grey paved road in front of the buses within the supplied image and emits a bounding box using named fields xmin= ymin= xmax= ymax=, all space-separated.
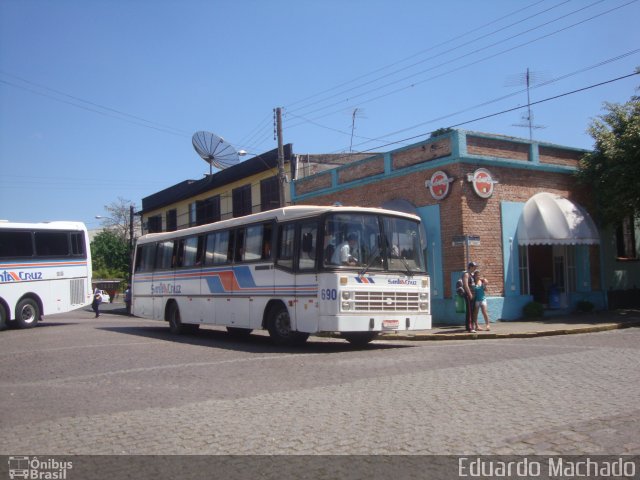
xmin=0 ymin=306 xmax=640 ymax=455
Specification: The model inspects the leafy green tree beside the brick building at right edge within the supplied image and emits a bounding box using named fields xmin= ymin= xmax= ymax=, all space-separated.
xmin=577 ymin=86 xmax=640 ymax=225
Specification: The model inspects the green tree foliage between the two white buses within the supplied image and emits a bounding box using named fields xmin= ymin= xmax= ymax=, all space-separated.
xmin=91 ymin=230 xmax=129 ymax=279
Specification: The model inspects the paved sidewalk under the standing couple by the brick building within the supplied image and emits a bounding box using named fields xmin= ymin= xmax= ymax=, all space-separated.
xmin=382 ymin=309 xmax=640 ymax=340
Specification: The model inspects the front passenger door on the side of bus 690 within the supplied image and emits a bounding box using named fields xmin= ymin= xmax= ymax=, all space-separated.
xmin=294 ymin=220 xmax=319 ymax=332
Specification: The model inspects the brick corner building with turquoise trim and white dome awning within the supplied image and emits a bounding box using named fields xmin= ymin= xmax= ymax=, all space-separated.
xmin=291 ymin=130 xmax=606 ymax=324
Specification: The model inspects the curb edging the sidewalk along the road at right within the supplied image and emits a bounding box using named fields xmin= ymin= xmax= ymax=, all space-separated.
xmin=378 ymin=320 xmax=640 ymax=341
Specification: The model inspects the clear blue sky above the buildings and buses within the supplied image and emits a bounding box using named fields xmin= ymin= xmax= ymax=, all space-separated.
xmin=0 ymin=0 xmax=640 ymax=229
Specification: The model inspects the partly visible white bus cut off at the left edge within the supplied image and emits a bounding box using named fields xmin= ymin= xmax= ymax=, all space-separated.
xmin=0 ymin=221 xmax=92 ymax=328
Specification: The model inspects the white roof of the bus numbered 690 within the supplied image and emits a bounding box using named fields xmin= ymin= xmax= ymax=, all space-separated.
xmin=138 ymin=205 xmax=420 ymax=243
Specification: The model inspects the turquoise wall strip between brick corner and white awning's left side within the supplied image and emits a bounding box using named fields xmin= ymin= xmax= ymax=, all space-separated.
xmin=500 ymin=202 xmax=524 ymax=297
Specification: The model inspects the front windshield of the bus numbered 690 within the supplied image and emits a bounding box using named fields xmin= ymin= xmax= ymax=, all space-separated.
xmin=323 ymin=213 xmax=425 ymax=274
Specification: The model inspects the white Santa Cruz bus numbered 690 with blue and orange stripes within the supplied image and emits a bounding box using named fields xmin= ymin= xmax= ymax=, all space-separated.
xmin=132 ymin=206 xmax=431 ymax=344
